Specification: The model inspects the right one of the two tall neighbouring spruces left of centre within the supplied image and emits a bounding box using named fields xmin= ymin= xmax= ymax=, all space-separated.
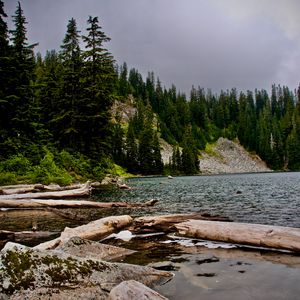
xmin=81 ymin=16 xmax=116 ymax=158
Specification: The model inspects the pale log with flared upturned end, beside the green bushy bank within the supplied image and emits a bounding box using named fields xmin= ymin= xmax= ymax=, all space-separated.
xmin=0 ymin=181 xmax=91 ymax=200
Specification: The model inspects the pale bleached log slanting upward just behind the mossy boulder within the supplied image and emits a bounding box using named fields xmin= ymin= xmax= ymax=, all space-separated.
xmin=34 ymin=215 xmax=132 ymax=250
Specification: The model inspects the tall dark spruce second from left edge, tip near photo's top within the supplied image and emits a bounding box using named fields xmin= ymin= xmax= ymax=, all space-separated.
xmin=7 ymin=2 xmax=37 ymax=157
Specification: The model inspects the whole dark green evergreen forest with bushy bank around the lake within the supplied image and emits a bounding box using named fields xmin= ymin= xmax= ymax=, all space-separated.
xmin=0 ymin=0 xmax=300 ymax=184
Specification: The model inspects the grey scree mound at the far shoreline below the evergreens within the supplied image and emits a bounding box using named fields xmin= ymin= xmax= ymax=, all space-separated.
xmin=200 ymin=138 xmax=271 ymax=174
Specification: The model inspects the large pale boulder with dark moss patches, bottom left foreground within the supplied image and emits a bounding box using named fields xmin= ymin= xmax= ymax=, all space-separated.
xmin=0 ymin=244 xmax=173 ymax=300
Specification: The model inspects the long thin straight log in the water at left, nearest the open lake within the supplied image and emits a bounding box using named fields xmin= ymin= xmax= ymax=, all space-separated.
xmin=0 ymin=197 xmax=157 ymax=208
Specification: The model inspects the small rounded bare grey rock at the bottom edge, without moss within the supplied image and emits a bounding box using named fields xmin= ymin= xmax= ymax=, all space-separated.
xmin=108 ymin=280 xmax=168 ymax=300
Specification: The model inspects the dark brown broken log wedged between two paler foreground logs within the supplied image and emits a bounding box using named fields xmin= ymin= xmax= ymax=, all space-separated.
xmin=133 ymin=213 xmax=230 ymax=232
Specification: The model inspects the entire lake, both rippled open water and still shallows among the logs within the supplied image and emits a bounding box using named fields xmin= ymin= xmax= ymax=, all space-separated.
xmin=0 ymin=173 xmax=300 ymax=300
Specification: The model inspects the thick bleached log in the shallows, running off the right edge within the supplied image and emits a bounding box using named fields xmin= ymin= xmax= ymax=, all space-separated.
xmin=175 ymin=220 xmax=300 ymax=252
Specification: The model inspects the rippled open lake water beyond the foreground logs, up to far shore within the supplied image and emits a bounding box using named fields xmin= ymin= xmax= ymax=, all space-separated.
xmin=99 ymin=173 xmax=300 ymax=227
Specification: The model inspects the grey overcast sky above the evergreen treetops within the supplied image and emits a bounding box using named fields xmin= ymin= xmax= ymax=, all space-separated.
xmin=4 ymin=0 xmax=300 ymax=92
